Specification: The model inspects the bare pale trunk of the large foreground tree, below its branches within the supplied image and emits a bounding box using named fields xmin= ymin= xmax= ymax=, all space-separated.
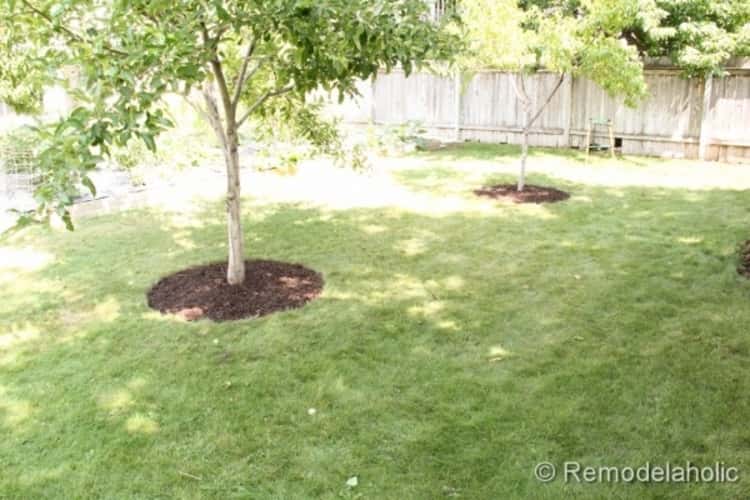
xmin=225 ymin=126 xmax=245 ymax=285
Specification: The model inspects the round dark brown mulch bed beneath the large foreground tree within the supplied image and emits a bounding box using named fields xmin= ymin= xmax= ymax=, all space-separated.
xmin=148 ymin=260 xmax=323 ymax=321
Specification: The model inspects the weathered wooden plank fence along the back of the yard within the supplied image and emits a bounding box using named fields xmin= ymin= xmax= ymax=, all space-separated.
xmin=340 ymin=60 xmax=750 ymax=162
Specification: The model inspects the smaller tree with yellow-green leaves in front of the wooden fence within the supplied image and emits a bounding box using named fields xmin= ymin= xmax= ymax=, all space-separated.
xmin=462 ymin=0 xmax=660 ymax=191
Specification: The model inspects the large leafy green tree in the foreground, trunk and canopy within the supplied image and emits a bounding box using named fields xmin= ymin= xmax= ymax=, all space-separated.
xmin=0 ymin=0 xmax=453 ymax=284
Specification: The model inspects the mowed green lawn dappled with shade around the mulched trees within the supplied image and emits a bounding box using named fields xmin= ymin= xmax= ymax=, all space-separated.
xmin=0 ymin=143 xmax=750 ymax=499
